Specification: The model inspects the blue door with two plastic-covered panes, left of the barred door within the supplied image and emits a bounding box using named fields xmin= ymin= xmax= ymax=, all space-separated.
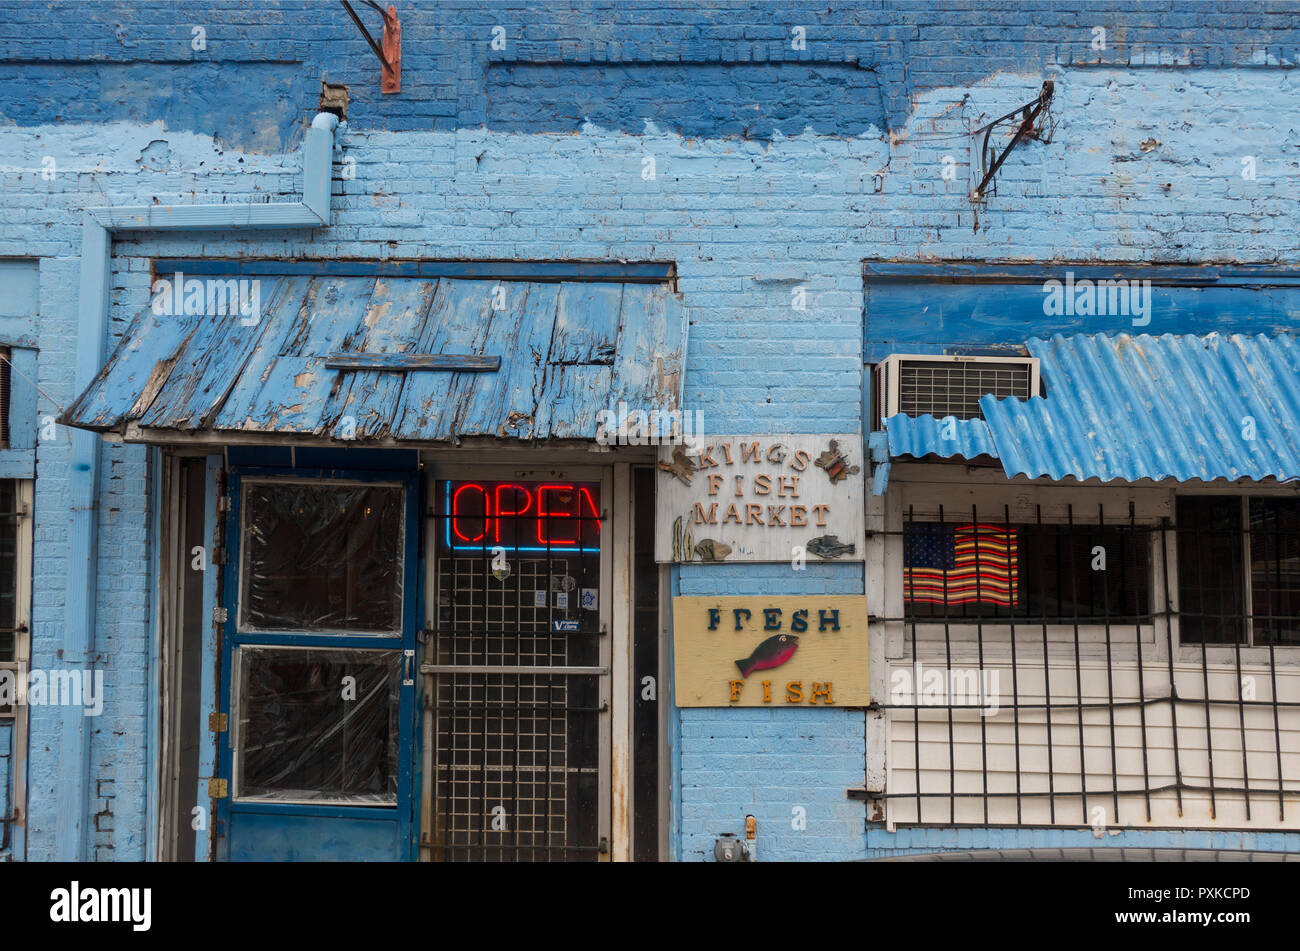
xmin=215 ymin=468 xmax=421 ymax=861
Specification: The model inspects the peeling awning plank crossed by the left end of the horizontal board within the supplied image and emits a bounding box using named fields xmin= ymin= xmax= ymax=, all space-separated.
xmin=321 ymin=278 xmax=438 ymax=439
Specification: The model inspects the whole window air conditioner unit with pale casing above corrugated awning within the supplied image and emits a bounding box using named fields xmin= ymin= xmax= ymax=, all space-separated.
xmin=876 ymin=353 xmax=1039 ymax=429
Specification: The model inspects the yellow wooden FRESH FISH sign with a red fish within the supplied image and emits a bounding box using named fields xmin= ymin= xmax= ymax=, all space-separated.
xmin=672 ymin=595 xmax=871 ymax=709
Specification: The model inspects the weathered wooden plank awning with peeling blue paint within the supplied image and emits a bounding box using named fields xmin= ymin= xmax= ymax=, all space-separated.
xmin=60 ymin=275 xmax=685 ymax=442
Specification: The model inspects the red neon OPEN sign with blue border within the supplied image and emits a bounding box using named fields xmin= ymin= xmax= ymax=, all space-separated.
xmin=441 ymin=482 xmax=601 ymax=552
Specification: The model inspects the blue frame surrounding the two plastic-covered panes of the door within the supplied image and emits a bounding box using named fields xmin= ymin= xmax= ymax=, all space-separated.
xmin=216 ymin=465 xmax=424 ymax=861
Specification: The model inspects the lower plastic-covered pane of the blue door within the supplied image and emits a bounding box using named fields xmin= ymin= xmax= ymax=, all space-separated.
xmin=235 ymin=647 xmax=402 ymax=805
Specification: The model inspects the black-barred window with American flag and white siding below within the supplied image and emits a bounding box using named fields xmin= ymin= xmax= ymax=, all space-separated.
xmin=872 ymin=495 xmax=1300 ymax=828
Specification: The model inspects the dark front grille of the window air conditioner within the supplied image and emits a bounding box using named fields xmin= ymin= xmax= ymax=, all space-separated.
xmin=894 ymin=360 xmax=1032 ymax=420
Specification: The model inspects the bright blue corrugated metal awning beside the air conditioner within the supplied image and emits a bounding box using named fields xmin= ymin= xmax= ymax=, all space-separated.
xmin=885 ymin=334 xmax=1300 ymax=482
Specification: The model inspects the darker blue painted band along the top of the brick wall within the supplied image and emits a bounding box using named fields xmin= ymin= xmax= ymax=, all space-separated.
xmin=0 ymin=0 xmax=1300 ymax=152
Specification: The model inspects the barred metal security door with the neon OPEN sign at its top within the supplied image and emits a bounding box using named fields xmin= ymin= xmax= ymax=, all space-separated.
xmin=420 ymin=473 xmax=610 ymax=861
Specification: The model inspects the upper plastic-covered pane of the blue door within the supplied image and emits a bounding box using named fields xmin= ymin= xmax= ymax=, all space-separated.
xmin=239 ymin=481 xmax=406 ymax=634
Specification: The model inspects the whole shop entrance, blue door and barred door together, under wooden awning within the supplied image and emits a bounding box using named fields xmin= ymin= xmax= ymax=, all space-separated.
xmin=209 ymin=451 xmax=642 ymax=861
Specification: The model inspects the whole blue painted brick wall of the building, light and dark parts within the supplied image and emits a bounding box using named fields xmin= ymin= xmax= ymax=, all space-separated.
xmin=0 ymin=0 xmax=1300 ymax=859
